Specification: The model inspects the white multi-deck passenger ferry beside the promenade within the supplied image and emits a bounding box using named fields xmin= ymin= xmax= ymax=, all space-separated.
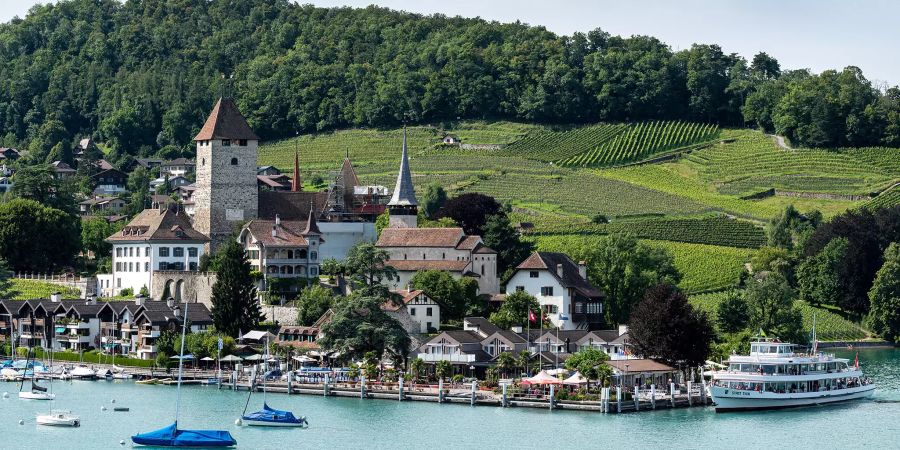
xmin=709 ymin=338 xmax=875 ymax=412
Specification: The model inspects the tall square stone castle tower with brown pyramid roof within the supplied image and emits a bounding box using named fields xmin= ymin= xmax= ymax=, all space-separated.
xmin=194 ymin=97 xmax=259 ymax=253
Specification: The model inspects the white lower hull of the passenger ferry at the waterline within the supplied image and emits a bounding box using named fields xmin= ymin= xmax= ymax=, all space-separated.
xmin=710 ymin=385 xmax=875 ymax=412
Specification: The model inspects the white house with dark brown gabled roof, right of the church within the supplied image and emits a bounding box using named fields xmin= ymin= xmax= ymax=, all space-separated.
xmin=506 ymin=252 xmax=604 ymax=330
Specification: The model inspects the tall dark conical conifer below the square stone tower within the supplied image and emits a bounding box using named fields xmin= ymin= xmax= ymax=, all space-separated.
xmin=212 ymin=240 xmax=263 ymax=336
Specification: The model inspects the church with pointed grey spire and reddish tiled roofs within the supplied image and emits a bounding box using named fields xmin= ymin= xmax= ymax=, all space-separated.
xmin=375 ymin=132 xmax=500 ymax=294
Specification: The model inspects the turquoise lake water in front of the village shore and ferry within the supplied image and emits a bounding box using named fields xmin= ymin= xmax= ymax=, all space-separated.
xmin=0 ymin=350 xmax=900 ymax=450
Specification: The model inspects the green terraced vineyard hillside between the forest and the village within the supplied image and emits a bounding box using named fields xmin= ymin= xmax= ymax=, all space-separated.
xmin=259 ymin=121 xmax=900 ymax=298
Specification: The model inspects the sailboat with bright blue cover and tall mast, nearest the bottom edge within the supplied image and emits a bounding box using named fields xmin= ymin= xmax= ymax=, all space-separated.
xmin=131 ymin=302 xmax=237 ymax=447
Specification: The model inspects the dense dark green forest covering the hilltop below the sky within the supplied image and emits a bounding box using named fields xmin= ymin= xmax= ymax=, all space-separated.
xmin=0 ymin=0 xmax=900 ymax=162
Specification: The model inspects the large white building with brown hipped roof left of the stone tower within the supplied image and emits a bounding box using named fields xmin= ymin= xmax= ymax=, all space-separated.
xmin=106 ymin=204 xmax=209 ymax=301
